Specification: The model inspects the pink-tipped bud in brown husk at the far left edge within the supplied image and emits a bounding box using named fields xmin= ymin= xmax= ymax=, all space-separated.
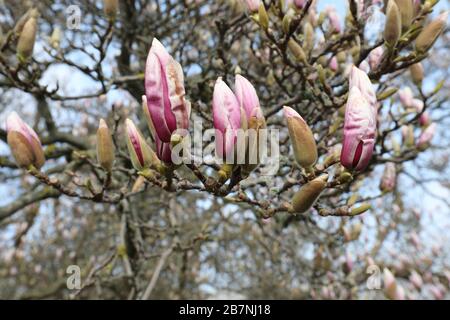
xmin=6 ymin=112 xmax=45 ymax=169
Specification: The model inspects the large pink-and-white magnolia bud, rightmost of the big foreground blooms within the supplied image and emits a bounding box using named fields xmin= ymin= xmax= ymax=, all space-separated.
xmin=341 ymin=86 xmax=376 ymax=171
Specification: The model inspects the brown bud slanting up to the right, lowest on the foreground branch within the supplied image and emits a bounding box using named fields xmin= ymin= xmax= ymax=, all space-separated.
xmin=292 ymin=174 xmax=328 ymax=213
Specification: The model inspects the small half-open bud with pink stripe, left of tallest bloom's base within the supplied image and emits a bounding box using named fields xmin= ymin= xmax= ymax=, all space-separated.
xmin=125 ymin=119 xmax=157 ymax=171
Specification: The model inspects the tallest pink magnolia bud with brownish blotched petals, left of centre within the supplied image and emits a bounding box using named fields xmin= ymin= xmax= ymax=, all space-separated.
xmin=145 ymin=38 xmax=191 ymax=143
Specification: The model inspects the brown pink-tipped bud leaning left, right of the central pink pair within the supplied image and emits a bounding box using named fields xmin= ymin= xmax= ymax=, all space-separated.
xmin=284 ymin=107 xmax=317 ymax=168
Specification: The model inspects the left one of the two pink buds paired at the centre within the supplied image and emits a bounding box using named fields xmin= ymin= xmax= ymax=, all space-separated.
xmin=213 ymin=77 xmax=241 ymax=158
